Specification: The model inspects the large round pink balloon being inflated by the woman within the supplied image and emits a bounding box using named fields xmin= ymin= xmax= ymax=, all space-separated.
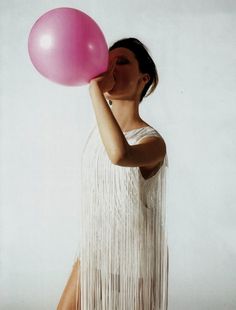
xmin=28 ymin=8 xmax=108 ymax=86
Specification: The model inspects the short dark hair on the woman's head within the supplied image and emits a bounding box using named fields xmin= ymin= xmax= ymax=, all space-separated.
xmin=109 ymin=38 xmax=159 ymax=104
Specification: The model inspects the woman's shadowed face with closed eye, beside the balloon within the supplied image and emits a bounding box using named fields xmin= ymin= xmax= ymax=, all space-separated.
xmin=104 ymin=47 xmax=148 ymax=100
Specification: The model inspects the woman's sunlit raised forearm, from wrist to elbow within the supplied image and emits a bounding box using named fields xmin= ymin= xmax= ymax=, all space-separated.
xmin=89 ymin=81 xmax=128 ymax=163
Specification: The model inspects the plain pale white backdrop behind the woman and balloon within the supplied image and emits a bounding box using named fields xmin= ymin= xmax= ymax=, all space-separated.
xmin=0 ymin=0 xmax=236 ymax=310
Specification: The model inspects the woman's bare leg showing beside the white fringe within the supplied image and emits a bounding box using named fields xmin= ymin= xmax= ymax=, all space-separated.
xmin=57 ymin=259 xmax=81 ymax=310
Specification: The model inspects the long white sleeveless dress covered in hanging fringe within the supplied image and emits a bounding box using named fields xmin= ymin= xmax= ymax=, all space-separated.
xmin=75 ymin=124 xmax=169 ymax=310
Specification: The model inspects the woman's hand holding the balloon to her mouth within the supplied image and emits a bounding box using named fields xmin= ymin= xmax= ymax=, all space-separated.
xmin=89 ymin=58 xmax=116 ymax=93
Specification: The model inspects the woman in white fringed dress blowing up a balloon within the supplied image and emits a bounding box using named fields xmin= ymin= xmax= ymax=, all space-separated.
xmin=57 ymin=38 xmax=168 ymax=310
